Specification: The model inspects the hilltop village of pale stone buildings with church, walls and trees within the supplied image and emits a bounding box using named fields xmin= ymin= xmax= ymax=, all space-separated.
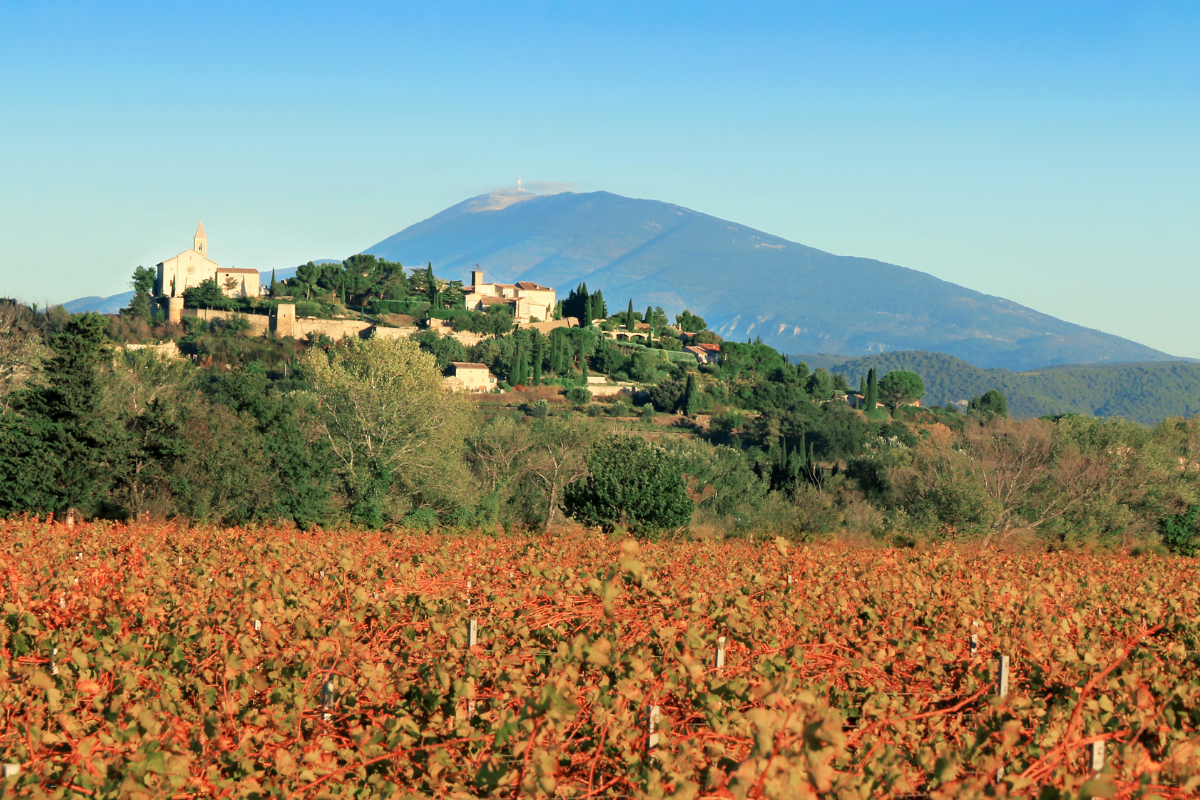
xmin=138 ymin=222 xmax=768 ymax=404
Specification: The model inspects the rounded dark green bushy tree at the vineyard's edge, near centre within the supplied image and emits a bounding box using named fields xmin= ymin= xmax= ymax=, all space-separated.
xmin=564 ymin=435 xmax=694 ymax=534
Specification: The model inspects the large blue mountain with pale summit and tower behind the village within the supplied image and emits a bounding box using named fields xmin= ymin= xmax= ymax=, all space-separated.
xmin=365 ymin=192 xmax=1171 ymax=369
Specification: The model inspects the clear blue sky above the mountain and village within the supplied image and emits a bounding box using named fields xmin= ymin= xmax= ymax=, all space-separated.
xmin=0 ymin=0 xmax=1200 ymax=357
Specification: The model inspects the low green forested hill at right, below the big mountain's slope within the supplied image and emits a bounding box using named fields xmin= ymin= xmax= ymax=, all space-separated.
xmin=811 ymin=350 xmax=1200 ymax=425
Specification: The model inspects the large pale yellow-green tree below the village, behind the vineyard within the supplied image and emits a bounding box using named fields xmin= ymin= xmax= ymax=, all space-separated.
xmin=301 ymin=339 xmax=469 ymax=525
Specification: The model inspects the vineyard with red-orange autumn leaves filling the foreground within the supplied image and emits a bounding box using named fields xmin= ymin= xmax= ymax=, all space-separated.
xmin=0 ymin=522 xmax=1200 ymax=799
